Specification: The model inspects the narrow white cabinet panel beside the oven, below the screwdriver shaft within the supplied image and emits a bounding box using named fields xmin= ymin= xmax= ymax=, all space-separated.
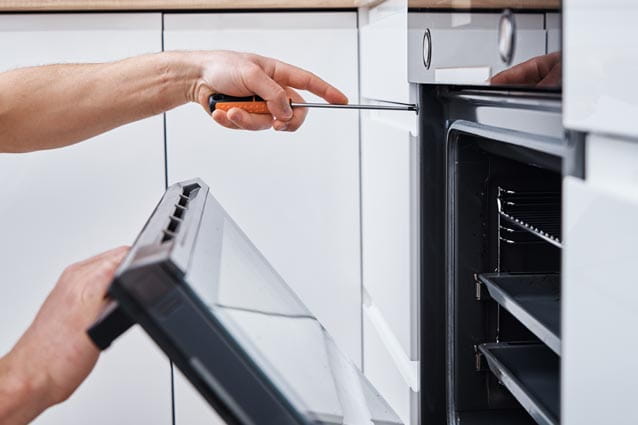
xmin=361 ymin=107 xmax=420 ymax=359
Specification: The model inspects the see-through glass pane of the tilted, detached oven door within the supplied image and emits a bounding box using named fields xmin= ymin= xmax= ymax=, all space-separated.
xmin=192 ymin=218 xmax=401 ymax=425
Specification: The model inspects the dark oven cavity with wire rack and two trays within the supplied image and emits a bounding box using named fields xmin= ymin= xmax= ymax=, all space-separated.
xmin=447 ymin=133 xmax=562 ymax=425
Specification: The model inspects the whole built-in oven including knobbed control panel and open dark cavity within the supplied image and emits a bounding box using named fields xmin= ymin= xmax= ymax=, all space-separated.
xmin=407 ymin=0 xmax=572 ymax=425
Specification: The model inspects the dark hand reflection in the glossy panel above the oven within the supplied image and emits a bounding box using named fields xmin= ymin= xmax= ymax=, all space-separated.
xmin=490 ymin=52 xmax=562 ymax=87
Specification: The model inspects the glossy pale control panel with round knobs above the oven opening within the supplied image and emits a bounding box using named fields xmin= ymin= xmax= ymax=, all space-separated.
xmin=408 ymin=12 xmax=546 ymax=85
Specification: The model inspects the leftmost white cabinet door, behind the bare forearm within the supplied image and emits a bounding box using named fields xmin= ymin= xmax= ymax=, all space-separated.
xmin=0 ymin=14 xmax=171 ymax=425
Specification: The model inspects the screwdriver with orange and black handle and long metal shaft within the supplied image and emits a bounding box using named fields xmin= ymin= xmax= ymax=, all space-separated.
xmin=208 ymin=94 xmax=417 ymax=114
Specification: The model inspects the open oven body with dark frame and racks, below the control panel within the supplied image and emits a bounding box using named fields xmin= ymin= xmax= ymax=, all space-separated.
xmin=419 ymin=85 xmax=583 ymax=425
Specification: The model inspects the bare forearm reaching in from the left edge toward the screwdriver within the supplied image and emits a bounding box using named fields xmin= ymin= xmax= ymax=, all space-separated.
xmin=0 ymin=52 xmax=200 ymax=152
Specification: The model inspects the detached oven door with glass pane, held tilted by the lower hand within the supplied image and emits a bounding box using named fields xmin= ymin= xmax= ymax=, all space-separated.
xmin=89 ymin=180 xmax=401 ymax=425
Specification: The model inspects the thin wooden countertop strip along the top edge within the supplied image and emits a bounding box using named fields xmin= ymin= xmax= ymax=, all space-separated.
xmin=0 ymin=0 xmax=560 ymax=12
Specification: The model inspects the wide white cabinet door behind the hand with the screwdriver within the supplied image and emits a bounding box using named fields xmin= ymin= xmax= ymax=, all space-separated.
xmin=164 ymin=12 xmax=361 ymax=424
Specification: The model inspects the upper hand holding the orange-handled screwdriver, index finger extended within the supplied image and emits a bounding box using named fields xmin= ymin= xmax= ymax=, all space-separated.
xmin=186 ymin=51 xmax=348 ymax=131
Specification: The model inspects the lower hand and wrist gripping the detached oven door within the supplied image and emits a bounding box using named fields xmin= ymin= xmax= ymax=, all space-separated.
xmin=0 ymin=247 xmax=128 ymax=424
